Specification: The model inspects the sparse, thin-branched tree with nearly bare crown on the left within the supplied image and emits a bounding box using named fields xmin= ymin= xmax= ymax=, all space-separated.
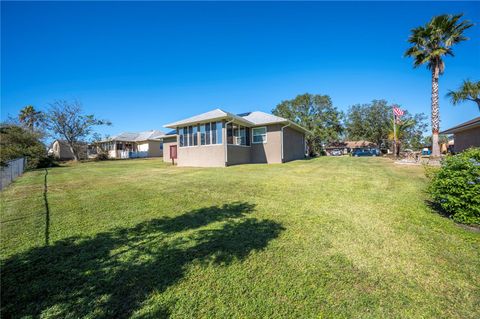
xmin=46 ymin=100 xmax=111 ymax=161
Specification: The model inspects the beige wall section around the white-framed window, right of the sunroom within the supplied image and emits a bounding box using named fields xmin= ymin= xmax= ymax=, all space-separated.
xmin=251 ymin=124 xmax=282 ymax=163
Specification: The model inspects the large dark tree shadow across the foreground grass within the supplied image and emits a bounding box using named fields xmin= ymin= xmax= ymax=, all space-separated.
xmin=1 ymin=203 xmax=284 ymax=318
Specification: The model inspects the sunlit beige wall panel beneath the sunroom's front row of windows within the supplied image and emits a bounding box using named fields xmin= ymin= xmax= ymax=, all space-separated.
xmin=177 ymin=144 xmax=225 ymax=167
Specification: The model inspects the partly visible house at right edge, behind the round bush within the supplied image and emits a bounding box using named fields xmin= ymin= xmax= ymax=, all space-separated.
xmin=440 ymin=117 xmax=480 ymax=153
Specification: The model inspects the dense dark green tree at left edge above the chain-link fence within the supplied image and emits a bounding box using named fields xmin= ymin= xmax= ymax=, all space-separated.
xmin=0 ymin=123 xmax=48 ymax=168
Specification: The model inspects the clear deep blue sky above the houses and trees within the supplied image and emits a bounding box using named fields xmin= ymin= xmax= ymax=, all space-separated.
xmin=1 ymin=2 xmax=480 ymax=134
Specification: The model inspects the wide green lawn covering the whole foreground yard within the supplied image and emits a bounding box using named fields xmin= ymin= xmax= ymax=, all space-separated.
xmin=1 ymin=157 xmax=480 ymax=318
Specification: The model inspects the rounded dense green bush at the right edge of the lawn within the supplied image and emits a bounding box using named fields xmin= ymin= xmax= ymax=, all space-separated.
xmin=428 ymin=148 xmax=480 ymax=225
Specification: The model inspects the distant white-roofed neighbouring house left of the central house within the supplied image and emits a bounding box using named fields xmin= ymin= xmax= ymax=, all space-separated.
xmin=90 ymin=130 xmax=165 ymax=158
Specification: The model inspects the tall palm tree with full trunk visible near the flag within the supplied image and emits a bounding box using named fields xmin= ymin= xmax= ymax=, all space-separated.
xmin=405 ymin=14 xmax=473 ymax=156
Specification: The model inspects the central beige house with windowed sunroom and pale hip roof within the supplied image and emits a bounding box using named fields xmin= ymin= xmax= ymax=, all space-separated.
xmin=164 ymin=109 xmax=308 ymax=167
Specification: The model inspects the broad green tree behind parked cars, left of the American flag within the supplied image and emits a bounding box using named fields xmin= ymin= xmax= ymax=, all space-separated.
xmin=346 ymin=100 xmax=392 ymax=147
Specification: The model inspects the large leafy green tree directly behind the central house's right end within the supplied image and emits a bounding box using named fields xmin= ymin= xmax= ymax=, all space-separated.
xmin=272 ymin=93 xmax=343 ymax=156
